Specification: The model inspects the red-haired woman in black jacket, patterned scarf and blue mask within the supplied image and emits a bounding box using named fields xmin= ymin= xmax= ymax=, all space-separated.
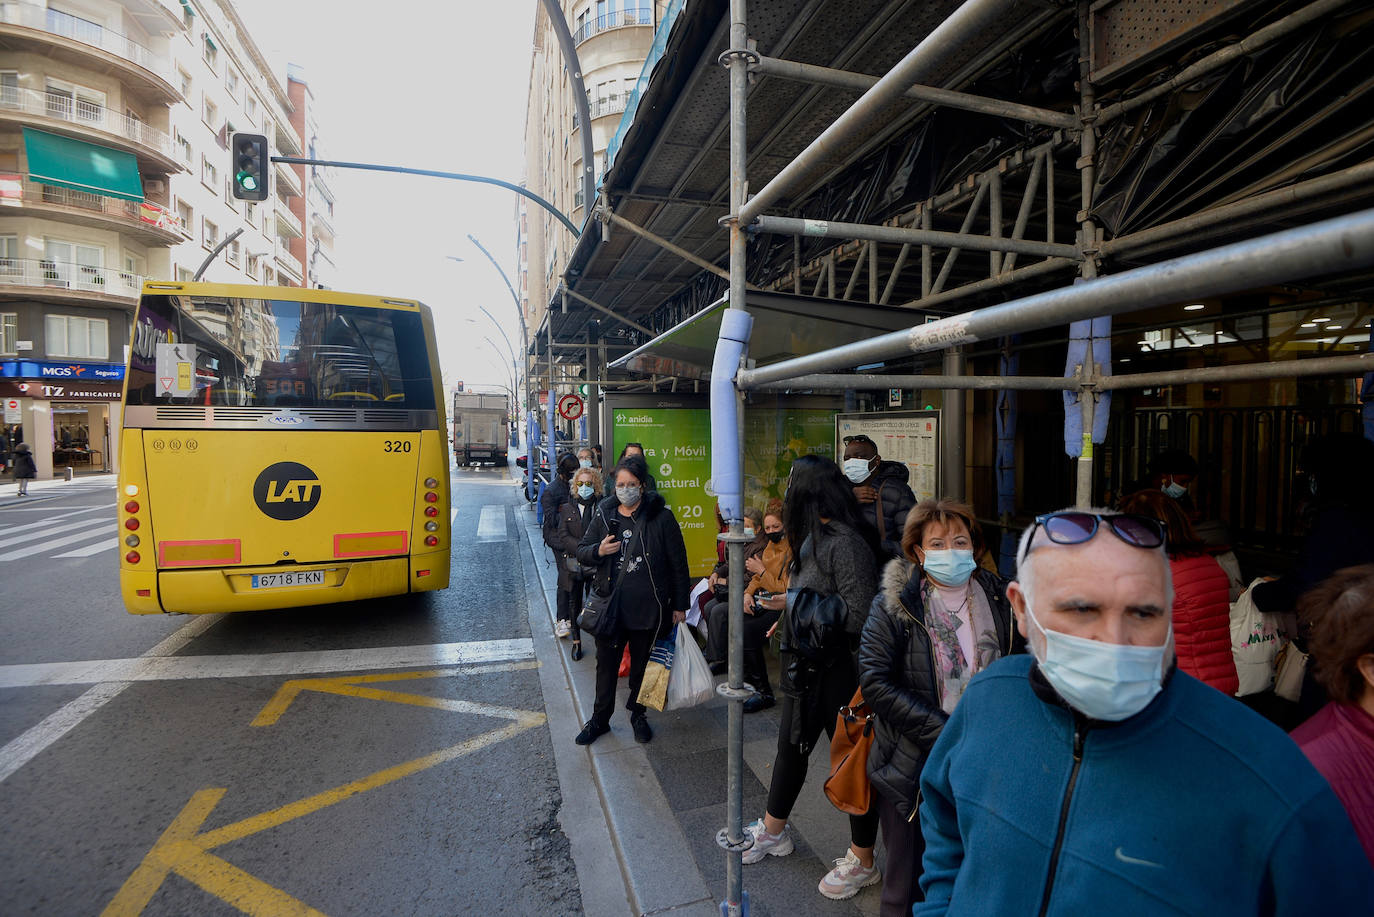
xmin=859 ymin=500 xmax=1024 ymax=917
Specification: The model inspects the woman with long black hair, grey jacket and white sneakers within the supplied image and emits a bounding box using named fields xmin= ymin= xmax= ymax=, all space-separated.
xmin=743 ymin=455 xmax=882 ymax=901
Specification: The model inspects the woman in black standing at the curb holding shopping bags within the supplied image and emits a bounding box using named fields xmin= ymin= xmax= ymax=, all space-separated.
xmin=577 ymin=455 xmax=691 ymax=745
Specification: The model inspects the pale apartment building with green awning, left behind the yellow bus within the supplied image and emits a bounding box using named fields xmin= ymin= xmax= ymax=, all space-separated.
xmin=0 ymin=0 xmax=333 ymax=478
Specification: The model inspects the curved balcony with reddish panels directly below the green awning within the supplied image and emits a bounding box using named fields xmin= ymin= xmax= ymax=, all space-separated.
xmin=0 ymin=173 xmax=183 ymax=245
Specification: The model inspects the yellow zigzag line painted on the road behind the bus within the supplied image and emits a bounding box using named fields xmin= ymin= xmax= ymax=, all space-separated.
xmin=102 ymin=663 xmax=547 ymax=917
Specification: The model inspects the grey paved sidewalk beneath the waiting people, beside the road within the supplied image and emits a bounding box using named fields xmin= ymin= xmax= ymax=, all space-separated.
xmin=515 ymin=507 xmax=882 ymax=917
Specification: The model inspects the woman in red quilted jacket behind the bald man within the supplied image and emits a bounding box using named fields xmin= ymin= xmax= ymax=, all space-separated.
xmin=1121 ymin=491 xmax=1241 ymax=696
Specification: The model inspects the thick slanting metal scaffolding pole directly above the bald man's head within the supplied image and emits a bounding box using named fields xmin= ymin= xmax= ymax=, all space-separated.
xmin=738 ymin=209 xmax=1374 ymax=389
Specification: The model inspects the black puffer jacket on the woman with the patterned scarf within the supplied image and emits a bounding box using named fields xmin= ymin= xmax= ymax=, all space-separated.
xmin=859 ymin=557 xmax=1024 ymax=818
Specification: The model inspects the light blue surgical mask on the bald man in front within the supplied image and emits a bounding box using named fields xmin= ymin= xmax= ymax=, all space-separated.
xmin=1026 ymin=602 xmax=1173 ymax=723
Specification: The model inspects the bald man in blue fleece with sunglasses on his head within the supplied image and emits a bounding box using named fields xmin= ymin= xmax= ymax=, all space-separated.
xmin=914 ymin=510 xmax=1374 ymax=917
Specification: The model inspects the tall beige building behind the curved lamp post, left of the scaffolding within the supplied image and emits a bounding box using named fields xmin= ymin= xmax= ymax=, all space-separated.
xmin=517 ymin=0 xmax=666 ymax=395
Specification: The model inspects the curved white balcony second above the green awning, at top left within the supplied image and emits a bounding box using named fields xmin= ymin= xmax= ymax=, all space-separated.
xmin=0 ymin=0 xmax=183 ymax=104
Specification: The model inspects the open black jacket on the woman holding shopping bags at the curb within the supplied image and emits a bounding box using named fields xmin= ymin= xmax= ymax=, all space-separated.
xmin=577 ymin=491 xmax=691 ymax=635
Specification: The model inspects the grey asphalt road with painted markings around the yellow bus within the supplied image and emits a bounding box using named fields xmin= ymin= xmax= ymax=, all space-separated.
xmin=0 ymin=469 xmax=583 ymax=917
